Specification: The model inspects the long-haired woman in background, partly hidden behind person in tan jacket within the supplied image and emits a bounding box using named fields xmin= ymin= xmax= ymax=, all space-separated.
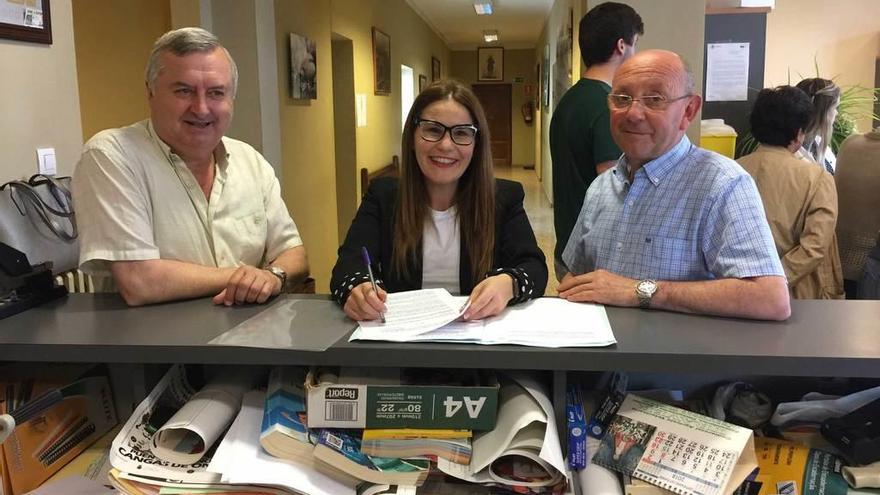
xmin=797 ymin=77 xmax=840 ymax=175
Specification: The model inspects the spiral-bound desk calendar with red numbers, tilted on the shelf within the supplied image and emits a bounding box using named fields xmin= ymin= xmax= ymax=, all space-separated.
xmin=593 ymin=394 xmax=758 ymax=495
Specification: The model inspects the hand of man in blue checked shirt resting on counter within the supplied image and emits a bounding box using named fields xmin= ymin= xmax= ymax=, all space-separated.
xmin=557 ymin=270 xmax=639 ymax=307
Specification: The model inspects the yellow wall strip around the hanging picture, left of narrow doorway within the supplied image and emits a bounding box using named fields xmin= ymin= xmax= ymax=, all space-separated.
xmin=275 ymin=0 xmax=339 ymax=293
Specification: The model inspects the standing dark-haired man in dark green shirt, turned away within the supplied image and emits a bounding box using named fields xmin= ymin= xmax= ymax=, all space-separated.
xmin=550 ymin=2 xmax=644 ymax=280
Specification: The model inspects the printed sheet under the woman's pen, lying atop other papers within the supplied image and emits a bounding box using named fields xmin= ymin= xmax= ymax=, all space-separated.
xmin=350 ymin=289 xmax=462 ymax=342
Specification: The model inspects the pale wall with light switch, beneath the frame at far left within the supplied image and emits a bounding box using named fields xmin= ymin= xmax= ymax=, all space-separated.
xmin=0 ymin=0 xmax=82 ymax=183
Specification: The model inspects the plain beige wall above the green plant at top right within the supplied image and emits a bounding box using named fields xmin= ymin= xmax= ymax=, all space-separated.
xmin=764 ymin=0 xmax=880 ymax=131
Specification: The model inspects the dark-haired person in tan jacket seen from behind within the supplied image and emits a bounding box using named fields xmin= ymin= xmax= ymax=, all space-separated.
xmin=737 ymin=86 xmax=843 ymax=299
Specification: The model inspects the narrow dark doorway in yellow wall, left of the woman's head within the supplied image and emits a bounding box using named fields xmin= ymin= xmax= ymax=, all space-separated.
xmin=330 ymin=33 xmax=360 ymax=242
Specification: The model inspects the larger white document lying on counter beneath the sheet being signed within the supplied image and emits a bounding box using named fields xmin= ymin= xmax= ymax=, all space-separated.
xmin=351 ymin=298 xmax=617 ymax=347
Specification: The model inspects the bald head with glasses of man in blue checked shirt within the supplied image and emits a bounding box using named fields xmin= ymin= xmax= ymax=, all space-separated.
xmin=610 ymin=50 xmax=701 ymax=169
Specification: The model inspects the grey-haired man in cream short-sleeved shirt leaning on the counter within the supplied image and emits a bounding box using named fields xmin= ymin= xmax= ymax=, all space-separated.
xmin=73 ymin=28 xmax=308 ymax=305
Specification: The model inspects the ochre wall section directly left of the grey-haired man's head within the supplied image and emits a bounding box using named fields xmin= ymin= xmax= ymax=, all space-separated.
xmin=72 ymin=0 xmax=171 ymax=140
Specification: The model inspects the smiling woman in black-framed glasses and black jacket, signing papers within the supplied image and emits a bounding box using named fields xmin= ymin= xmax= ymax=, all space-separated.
xmin=330 ymin=81 xmax=547 ymax=320
